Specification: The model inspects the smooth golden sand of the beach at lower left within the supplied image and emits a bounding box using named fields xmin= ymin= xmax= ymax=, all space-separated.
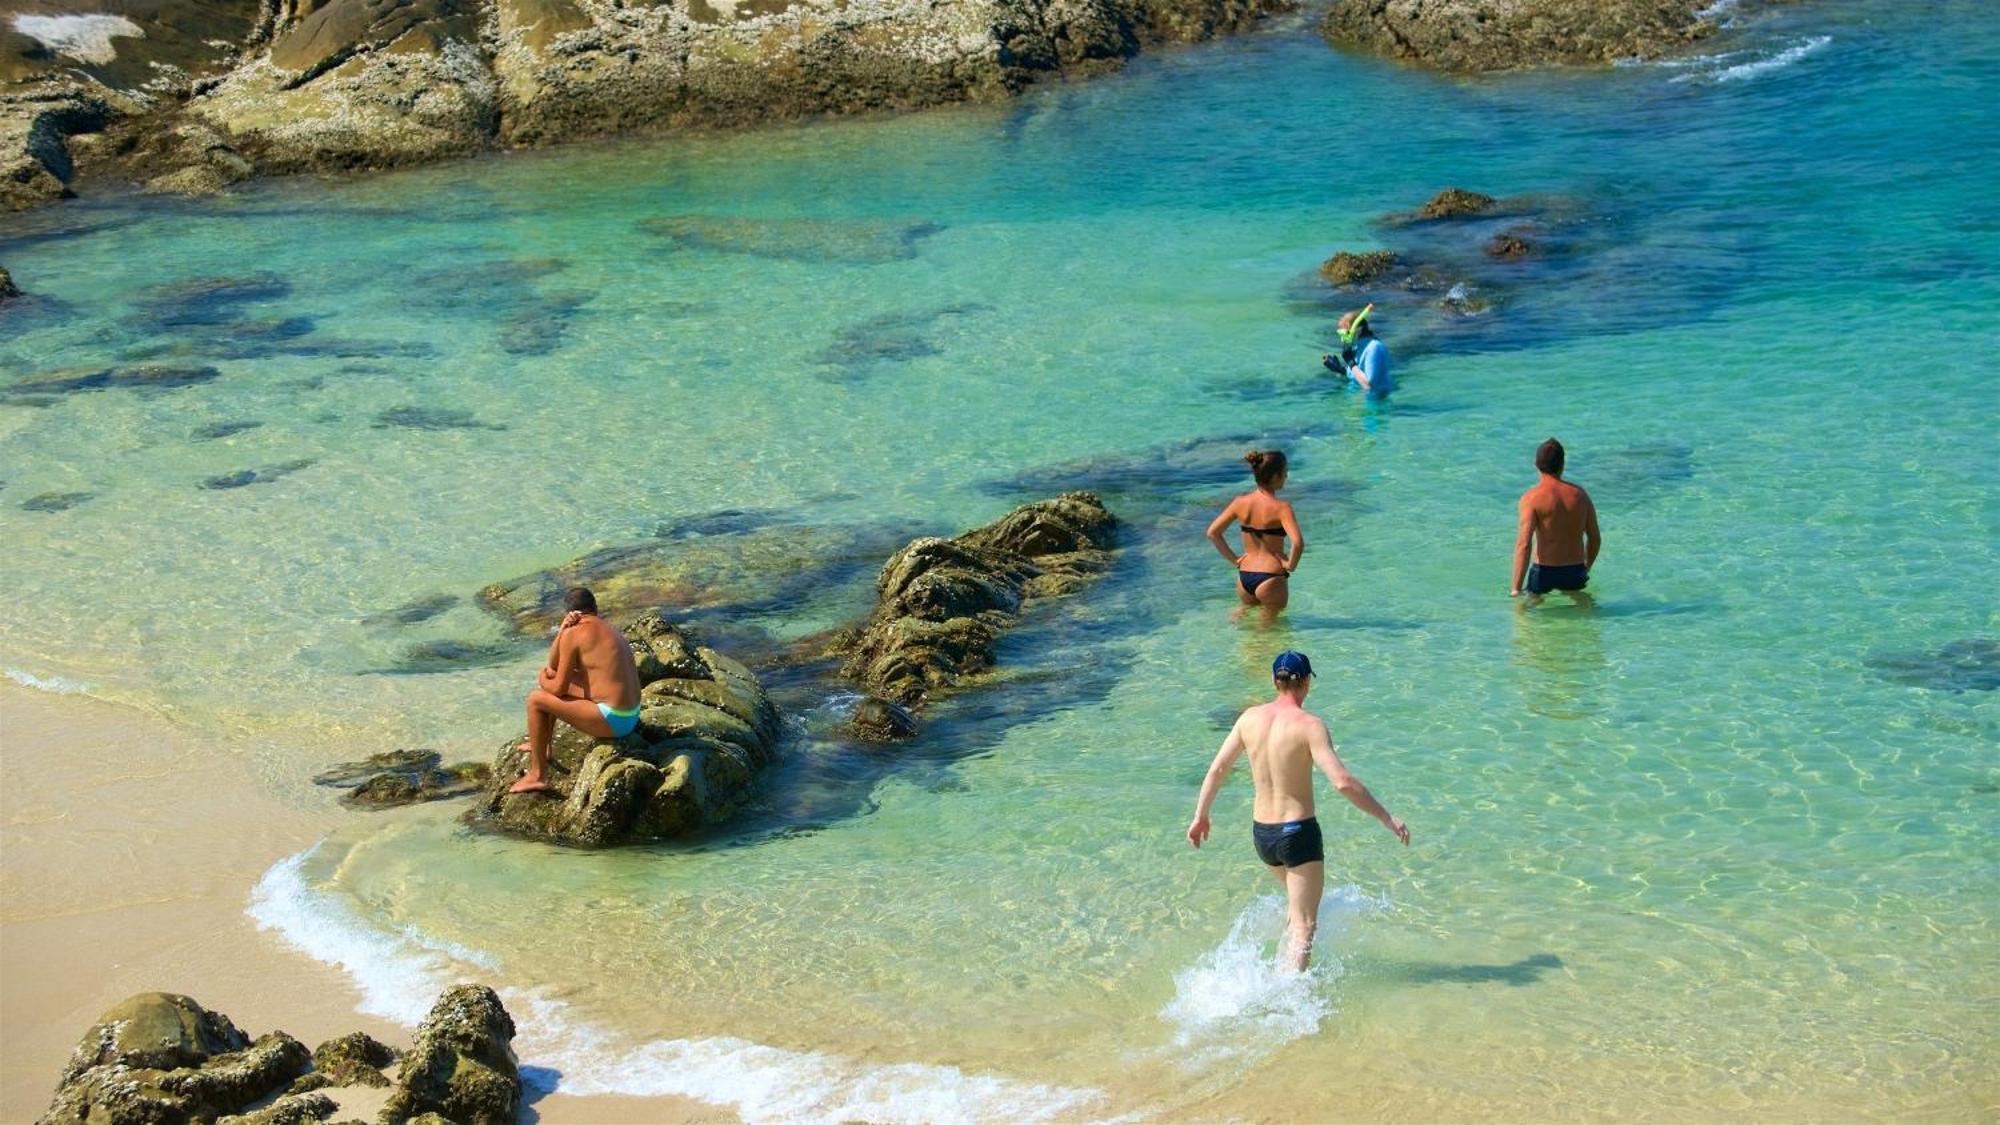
xmin=0 ymin=683 xmax=734 ymax=1125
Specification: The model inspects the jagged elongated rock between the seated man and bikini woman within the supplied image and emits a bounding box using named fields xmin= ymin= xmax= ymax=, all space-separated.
xmin=836 ymin=492 xmax=1118 ymax=707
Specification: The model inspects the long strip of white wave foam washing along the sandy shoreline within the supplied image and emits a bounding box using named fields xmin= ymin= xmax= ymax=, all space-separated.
xmin=250 ymin=845 xmax=1104 ymax=1123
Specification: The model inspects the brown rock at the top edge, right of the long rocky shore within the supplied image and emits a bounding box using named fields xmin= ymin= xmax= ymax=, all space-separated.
xmin=1320 ymin=0 xmax=1716 ymax=74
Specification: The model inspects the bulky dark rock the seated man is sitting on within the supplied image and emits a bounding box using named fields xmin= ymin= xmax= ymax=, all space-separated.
xmin=466 ymin=613 xmax=780 ymax=847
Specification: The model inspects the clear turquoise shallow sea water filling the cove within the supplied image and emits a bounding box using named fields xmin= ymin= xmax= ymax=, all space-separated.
xmin=0 ymin=4 xmax=2000 ymax=1119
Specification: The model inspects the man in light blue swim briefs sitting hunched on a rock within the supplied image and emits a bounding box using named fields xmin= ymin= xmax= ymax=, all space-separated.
xmin=508 ymin=587 xmax=638 ymax=793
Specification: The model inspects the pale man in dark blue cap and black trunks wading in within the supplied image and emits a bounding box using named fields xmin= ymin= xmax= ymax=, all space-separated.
xmin=1188 ymin=651 xmax=1410 ymax=971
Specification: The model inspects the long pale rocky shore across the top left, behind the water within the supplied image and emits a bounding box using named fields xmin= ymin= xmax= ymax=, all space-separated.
xmin=0 ymin=0 xmax=1294 ymax=208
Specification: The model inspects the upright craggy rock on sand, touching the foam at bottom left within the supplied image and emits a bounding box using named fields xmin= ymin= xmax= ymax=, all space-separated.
xmin=382 ymin=985 xmax=520 ymax=1125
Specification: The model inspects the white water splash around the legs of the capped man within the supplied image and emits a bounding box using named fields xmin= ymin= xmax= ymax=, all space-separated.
xmin=1160 ymin=885 xmax=1384 ymax=1065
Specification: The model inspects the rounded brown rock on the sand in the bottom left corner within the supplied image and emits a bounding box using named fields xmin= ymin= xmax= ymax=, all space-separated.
xmin=42 ymin=993 xmax=312 ymax=1125
